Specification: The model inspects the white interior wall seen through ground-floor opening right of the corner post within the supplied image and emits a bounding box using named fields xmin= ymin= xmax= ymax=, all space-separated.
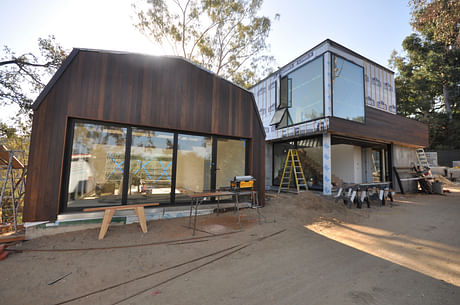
xmin=331 ymin=144 xmax=362 ymax=183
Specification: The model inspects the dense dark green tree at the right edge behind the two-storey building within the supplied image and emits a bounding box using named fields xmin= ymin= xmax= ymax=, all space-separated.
xmin=390 ymin=0 xmax=460 ymax=149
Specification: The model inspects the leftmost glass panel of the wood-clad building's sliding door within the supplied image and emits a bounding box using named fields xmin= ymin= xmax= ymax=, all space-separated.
xmin=67 ymin=122 xmax=127 ymax=208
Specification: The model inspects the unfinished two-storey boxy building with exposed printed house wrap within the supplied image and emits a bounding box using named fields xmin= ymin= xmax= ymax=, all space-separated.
xmin=251 ymin=39 xmax=428 ymax=194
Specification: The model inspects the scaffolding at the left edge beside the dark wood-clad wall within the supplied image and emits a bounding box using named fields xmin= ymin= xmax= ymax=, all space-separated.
xmin=0 ymin=145 xmax=27 ymax=233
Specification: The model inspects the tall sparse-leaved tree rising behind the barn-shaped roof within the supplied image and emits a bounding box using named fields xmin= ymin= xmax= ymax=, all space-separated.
xmin=133 ymin=0 xmax=278 ymax=88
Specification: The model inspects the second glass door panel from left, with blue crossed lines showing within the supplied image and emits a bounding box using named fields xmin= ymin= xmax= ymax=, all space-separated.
xmin=128 ymin=128 xmax=174 ymax=204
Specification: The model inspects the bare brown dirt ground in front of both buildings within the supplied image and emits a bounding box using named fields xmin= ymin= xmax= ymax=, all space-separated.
xmin=0 ymin=187 xmax=460 ymax=305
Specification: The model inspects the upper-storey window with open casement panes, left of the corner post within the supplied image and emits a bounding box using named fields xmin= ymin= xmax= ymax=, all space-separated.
xmin=278 ymin=56 xmax=324 ymax=127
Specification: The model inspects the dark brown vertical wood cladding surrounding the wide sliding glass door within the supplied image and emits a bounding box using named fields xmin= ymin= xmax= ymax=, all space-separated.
xmin=24 ymin=50 xmax=265 ymax=221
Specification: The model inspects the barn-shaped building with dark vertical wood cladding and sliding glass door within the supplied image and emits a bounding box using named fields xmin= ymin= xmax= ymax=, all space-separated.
xmin=24 ymin=49 xmax=265 ymax=222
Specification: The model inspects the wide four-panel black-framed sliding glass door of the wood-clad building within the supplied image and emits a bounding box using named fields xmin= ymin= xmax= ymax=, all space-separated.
xmin=62 ymin=120 xmax=248 ymax=210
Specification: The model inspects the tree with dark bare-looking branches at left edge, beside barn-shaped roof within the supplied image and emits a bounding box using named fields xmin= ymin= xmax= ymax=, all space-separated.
xmin=0 ymin=36 xmax=68 ymax=130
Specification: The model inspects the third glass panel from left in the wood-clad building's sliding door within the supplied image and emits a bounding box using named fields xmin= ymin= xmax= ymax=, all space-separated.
xmin=176 ymin=134 xmax=212 ymax=202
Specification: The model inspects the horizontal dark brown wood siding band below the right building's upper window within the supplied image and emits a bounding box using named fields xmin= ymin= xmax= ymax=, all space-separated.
xmin=329 ymin=106 xmax=429 ymax=147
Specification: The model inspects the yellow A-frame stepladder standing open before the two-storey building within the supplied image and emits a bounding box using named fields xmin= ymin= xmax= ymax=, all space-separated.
xmin=278 ymin=149 xmax=308 ymax=194
